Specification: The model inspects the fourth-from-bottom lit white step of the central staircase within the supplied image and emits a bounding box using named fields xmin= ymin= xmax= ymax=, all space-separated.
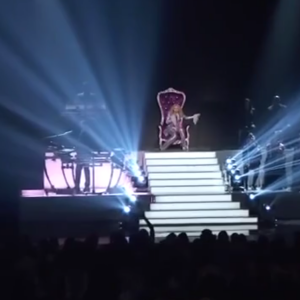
xmin=151 ymin=202 xmax=240 ymax=211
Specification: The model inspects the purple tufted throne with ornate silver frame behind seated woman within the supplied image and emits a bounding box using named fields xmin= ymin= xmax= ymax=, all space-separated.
xmin=157 ymin=88 xmax=190 ymax=146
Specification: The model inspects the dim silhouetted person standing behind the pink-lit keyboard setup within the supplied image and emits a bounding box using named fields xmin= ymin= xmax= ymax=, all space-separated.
xmin=75 ymin=122 xmax=91 ymax=193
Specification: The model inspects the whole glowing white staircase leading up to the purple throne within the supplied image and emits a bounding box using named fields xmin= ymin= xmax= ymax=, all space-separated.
xmin=140 ymin=152 xmax=258 ymax=238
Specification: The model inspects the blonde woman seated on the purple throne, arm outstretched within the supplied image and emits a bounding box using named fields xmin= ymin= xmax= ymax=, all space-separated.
xmin=161 ymin=104 xmax=200 ymax=150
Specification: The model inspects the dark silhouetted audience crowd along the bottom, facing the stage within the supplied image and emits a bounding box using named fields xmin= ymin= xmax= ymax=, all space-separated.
xmin=0 ymin=223 xmax=300 ymax=300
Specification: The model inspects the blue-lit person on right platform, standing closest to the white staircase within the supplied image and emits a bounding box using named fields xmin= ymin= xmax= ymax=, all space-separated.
xmin=243 ymin=133 xmax=262 ymax=190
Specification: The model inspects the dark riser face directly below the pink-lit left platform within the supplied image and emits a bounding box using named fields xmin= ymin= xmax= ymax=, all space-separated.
xmin=18 ymin=194 xmax=151 ymax=224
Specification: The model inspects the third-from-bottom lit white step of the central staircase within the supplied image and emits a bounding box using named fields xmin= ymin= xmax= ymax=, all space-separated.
xmin=145 ymin=209 xmax=249 ymax=220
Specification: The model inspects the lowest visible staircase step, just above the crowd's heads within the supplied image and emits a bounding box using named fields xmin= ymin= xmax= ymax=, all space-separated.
xmin=140 ymin=224 xmax=258 ymax=235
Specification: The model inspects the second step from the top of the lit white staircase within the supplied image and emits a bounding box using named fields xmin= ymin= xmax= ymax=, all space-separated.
xmin=146 ymin=158 xmax=218 ymax=166
